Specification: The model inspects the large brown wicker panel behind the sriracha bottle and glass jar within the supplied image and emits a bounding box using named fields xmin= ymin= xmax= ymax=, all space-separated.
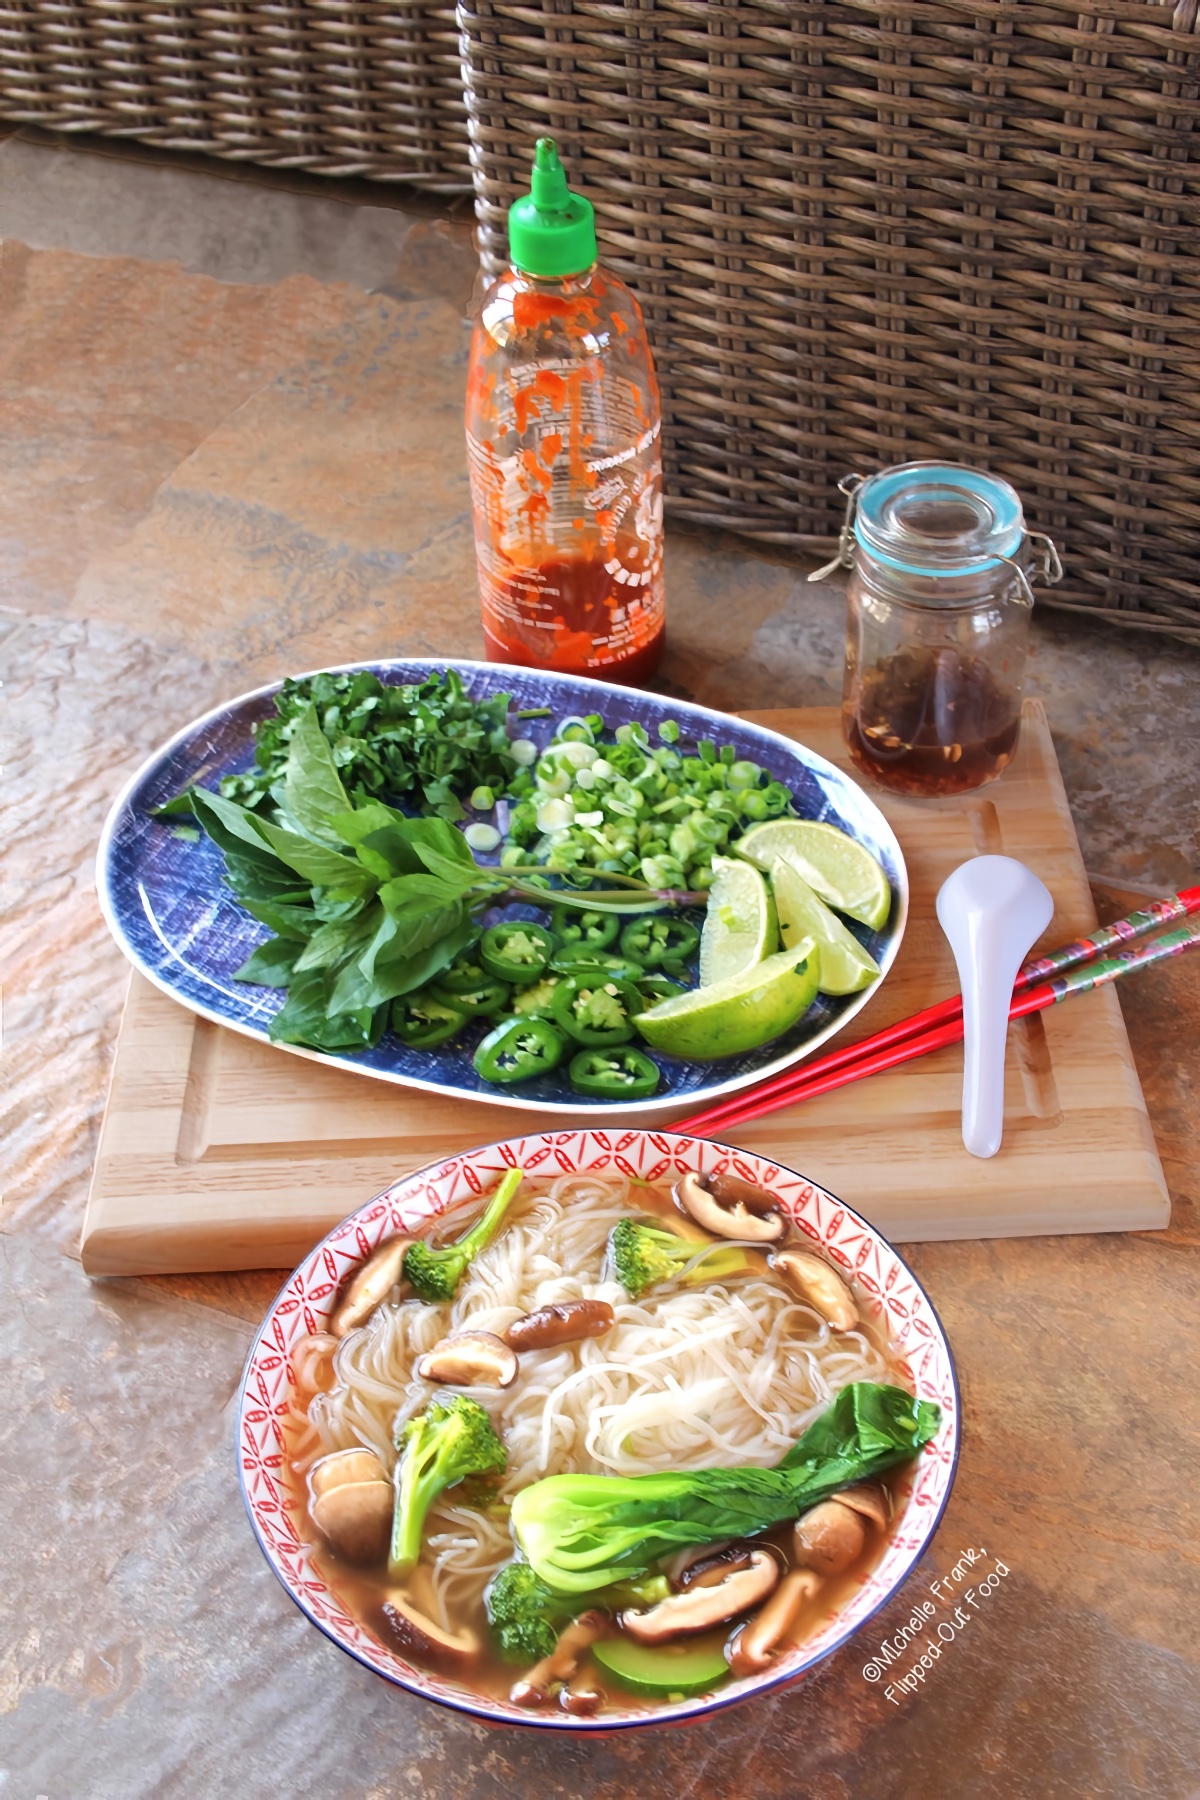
xmin=459 ymin=0 xmax=1200 ymax=643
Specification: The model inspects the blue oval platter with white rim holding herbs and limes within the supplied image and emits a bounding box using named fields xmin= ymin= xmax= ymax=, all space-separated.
xmin=97 ymin=661 xmax=909 ymax=1120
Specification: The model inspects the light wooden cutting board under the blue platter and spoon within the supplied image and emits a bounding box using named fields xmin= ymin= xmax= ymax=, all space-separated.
xmin=83 ymin=700 xmax=1169 ymax=1274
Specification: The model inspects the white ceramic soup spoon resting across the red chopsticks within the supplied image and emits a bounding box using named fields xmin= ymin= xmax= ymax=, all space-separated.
xmin=937 ymin=857 xmax=1054 ymax=1156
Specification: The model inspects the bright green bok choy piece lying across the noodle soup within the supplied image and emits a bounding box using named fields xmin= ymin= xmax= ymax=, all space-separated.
xmin=513 ymin=1381 xmax=941 ymax=1602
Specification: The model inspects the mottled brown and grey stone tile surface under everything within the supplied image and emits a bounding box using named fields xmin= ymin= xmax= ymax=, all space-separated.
xmin=0 ymin=139 xmax=1200 ymax=1800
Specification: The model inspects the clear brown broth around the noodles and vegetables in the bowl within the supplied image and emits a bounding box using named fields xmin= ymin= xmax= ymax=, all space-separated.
xmin=284 ymin=1186 xmax=909 ymax=1712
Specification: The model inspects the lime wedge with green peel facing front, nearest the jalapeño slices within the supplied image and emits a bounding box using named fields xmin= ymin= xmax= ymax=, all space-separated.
xmin=633 ymin=938 xmax=820 ymax=1062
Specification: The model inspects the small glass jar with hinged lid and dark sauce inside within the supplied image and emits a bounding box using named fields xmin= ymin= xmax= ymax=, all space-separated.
xmin=810 ymin=463 xmax=1061 ymax=794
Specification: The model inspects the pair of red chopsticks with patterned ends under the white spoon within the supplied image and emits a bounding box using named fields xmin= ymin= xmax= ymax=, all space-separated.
xmin=675 ymin=887 xmax=1200 ymax=1138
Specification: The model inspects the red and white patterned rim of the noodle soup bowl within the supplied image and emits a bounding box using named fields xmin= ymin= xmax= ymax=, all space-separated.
xmin=237 ymin=1130 xmax=959 ymax=1732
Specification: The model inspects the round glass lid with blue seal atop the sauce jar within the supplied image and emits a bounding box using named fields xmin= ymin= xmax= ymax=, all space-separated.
xmin=855 ymin=463 xmax=1025 ymax=576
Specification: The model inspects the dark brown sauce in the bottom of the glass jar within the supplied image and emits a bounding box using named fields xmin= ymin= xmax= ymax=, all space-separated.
xmin=844 ymin=644 xmax=1020 ymax=796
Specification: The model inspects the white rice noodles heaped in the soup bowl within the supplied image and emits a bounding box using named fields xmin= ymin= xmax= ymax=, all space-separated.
xmin=291 ymin=1175 xmax=891 ymax=1625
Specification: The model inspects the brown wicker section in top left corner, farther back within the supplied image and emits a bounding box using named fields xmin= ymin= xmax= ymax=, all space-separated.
xmin=0 ymin=0 xmax=471 ymax=193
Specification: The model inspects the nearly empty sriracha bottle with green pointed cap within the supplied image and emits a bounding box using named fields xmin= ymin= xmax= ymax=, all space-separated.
xmin=466 ymin=137 xmax=664 ymax=680
